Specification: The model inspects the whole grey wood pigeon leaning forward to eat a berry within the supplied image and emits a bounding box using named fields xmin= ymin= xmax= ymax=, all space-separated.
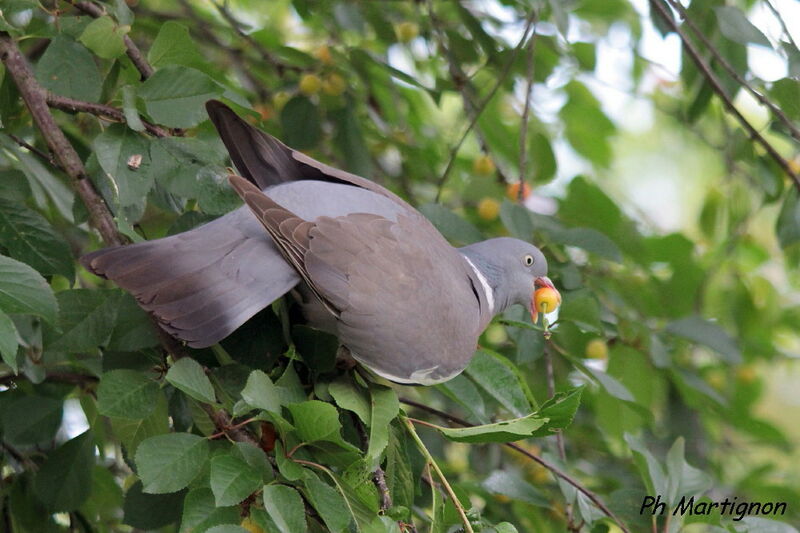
xmin=81 ymin=101 xmax=553 ymax=385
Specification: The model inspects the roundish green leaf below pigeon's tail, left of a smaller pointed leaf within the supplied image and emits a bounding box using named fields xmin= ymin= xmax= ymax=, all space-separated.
xmin=97 ymin=369 xmax=158 ymax=419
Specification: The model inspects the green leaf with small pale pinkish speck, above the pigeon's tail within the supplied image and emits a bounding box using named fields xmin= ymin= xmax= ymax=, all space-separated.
xmin=92 ymin=124 xmax=153 ymax=221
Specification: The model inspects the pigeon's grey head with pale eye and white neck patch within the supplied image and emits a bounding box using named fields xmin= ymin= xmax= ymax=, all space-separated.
xmin=459 ymin=237 xmax=555 ymax=315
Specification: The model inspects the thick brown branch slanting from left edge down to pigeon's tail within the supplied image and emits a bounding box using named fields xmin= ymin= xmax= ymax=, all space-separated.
xmin=0 ymin=32 xmax=126 ymax=246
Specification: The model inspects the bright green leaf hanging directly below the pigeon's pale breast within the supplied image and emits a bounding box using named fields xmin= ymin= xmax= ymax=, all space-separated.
xmin=465 ymin=351 xmax=531 ymax=416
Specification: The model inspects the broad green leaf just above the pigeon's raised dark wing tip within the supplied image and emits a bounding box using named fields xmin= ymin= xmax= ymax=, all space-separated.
xmin=139 ymin=65 xmax=224 ymax=128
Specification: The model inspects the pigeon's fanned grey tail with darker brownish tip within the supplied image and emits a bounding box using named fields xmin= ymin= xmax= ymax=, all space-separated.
xmin=81 ymin=208 xmax=299 ymax=348
